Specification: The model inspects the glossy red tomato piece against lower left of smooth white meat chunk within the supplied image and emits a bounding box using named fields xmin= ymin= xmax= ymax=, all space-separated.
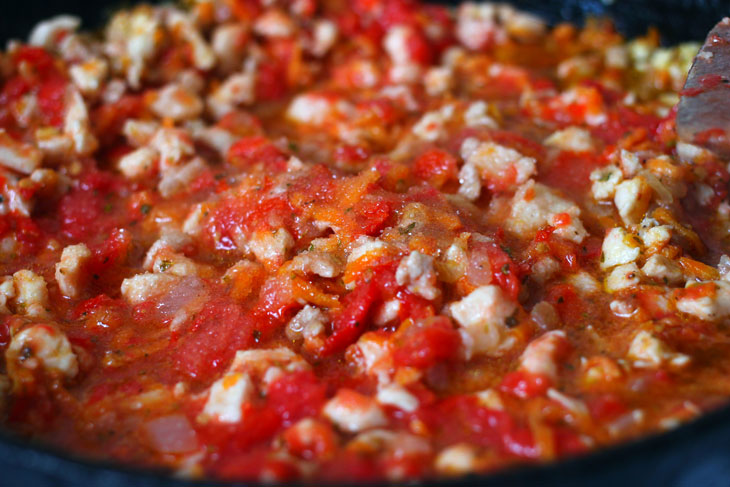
xmin=393 ymin=318 xmax=461 ymax=369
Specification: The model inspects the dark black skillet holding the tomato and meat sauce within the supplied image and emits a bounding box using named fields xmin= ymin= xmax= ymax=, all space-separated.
xmin=0 ymin=0 xmax=730 ymax=487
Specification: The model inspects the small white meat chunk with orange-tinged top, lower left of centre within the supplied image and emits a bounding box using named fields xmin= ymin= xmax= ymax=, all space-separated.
xmin=202 ymin=372 xmax=255 ymax=423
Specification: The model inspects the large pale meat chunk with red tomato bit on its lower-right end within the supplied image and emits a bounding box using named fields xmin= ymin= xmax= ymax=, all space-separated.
xmin=505 ymin=180 xmax=588 ymax=243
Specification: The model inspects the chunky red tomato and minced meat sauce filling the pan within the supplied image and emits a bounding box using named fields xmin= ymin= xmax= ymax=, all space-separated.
xmin=0 ymin=0 xmax=730 ymax=481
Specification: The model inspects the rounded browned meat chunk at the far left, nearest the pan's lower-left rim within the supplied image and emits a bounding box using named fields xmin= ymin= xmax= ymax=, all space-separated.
xmin=5 ymin=324 xmax=79 ymax=378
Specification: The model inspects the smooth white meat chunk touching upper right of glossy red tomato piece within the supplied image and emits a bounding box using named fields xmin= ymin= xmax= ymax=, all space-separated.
xmin=449 ymin=284 xmax=517 ymax=355
